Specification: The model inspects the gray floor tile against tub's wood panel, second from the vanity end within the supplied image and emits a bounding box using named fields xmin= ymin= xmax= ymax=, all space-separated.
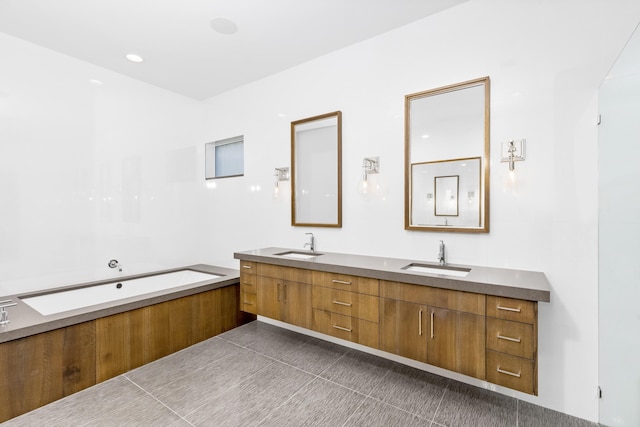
xmin=125 ymin=338 xmax=241 ymax=390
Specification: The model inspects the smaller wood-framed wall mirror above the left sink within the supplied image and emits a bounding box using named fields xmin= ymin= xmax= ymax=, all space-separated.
xmin=291 ymin=111 xmax=342 ymax=227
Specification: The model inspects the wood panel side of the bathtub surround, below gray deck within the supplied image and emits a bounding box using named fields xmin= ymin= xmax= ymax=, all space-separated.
xmin=0 ymin=284 xmax=252 ymax=422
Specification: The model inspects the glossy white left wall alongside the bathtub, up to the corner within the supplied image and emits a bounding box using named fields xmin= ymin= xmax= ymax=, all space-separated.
xmin=0 ymin=33 xmax=204 ymax=295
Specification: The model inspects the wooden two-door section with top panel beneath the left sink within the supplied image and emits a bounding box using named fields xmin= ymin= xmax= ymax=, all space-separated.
xmin=256 ymin=263 xmax=312 ymax=329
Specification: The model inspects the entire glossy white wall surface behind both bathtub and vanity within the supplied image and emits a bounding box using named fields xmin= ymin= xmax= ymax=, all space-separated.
xmin=0 ymin=0 xmax=640 ymax=420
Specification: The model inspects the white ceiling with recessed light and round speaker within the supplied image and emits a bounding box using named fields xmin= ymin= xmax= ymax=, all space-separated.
xmin=0 ymin=0 xmax=467 ymax=100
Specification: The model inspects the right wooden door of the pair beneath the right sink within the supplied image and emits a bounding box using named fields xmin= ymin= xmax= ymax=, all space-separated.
xmin=427 ymin=307 xmax=485 ymax=378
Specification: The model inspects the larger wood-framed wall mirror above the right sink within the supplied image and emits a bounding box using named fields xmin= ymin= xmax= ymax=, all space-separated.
xmin=405 ymin=77 xmax=489 ymax=233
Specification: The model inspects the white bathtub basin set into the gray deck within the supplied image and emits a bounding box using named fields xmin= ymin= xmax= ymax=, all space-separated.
xmin=20 ymin=270 xmax=222 ymax=316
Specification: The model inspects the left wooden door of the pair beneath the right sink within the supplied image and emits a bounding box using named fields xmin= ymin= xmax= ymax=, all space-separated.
xmin=380 ymin=298 xmax=427 ymax=362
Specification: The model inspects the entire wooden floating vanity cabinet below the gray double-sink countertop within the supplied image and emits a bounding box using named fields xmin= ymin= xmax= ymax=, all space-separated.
xmin=240 ymin=260 xmax=538 ymax=395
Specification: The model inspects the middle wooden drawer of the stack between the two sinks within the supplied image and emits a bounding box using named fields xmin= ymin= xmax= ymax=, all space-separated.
xmin=311 ymin=286 xmax=380 ymax=323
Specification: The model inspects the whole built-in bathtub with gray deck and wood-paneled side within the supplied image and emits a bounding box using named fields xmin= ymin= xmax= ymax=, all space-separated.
xmin=0 ymin=264 xmax=248 ymax=423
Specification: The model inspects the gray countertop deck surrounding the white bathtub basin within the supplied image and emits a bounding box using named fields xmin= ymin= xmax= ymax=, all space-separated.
xmin=0 ymin=264 xmax=240 ymax=343
